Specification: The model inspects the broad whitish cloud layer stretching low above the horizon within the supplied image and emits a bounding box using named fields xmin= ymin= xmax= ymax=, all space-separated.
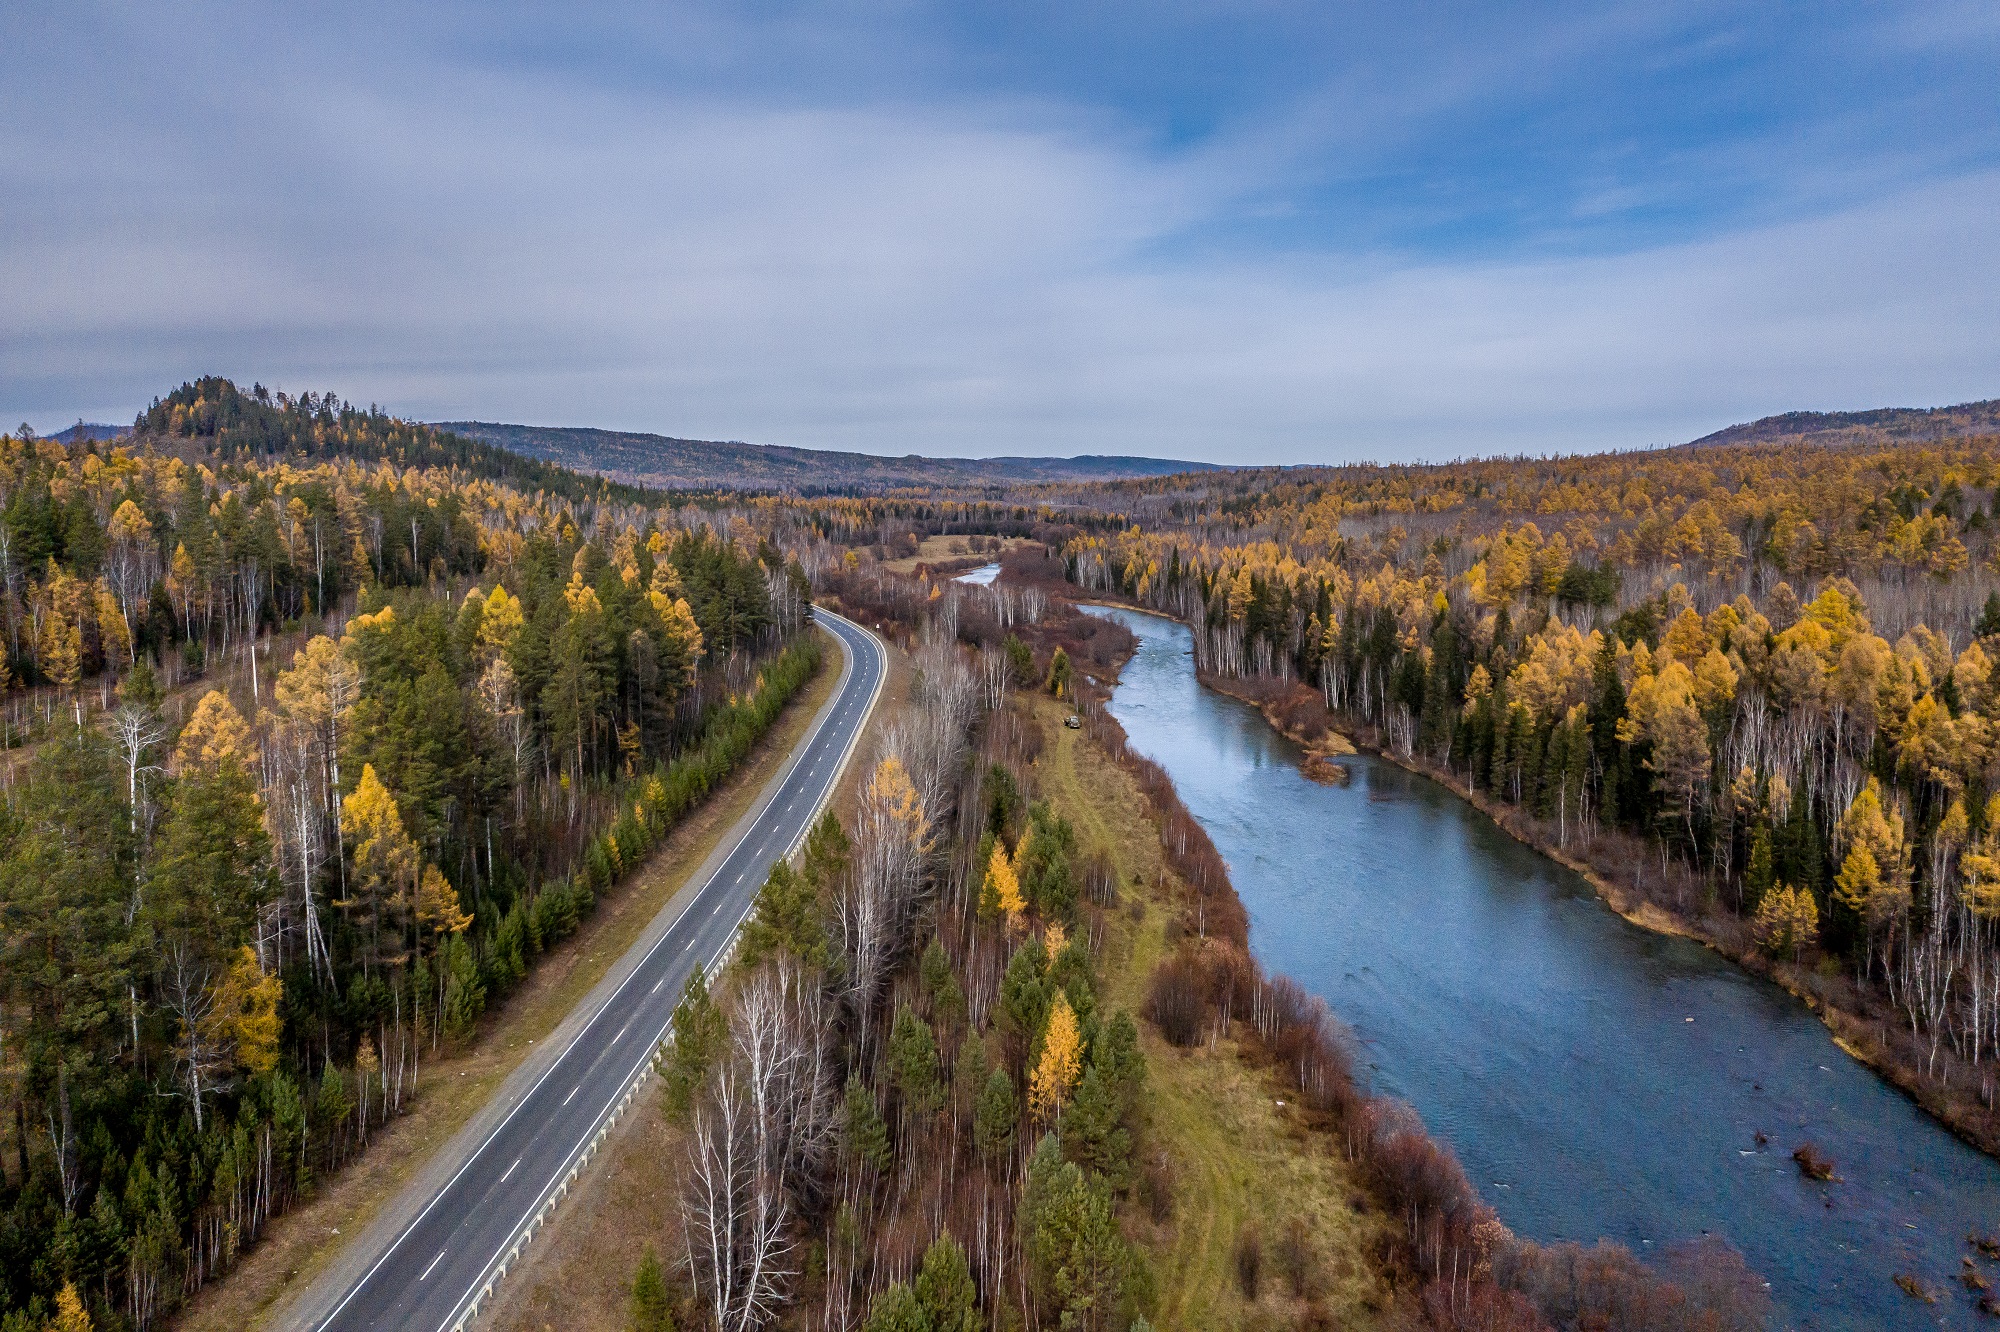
xmin=0 ymin=5 xmax=2000 ymax=462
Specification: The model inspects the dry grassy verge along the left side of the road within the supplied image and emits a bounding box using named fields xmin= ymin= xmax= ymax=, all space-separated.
xmin=164 ymin=632 xmax=840 ymax=1332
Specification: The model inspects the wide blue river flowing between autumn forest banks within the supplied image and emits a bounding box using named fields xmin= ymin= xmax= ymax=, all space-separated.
xmin=1100 ymin=610 xmax=2000 ymax=1328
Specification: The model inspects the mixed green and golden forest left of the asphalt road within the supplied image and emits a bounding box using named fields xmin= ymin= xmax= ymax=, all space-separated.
xmin=0 ymin=380 xmax=820 ymax=1332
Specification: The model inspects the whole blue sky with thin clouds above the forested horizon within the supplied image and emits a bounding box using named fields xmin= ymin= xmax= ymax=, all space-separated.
xmin=0 ymin=0 xmax=2000 ymax=464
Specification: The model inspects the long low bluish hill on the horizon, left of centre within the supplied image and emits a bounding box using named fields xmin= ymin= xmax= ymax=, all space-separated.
xmin=434 ymin=420 xmax=1222 ymax=492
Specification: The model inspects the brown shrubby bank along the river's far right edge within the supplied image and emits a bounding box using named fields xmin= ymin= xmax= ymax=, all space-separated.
xmin=1192 ymin=660 xmax=2000 ymax=1158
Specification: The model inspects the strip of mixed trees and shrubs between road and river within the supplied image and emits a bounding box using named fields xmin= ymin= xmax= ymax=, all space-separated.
xmin=624 ymin=552 xmax=1768 ymax=1332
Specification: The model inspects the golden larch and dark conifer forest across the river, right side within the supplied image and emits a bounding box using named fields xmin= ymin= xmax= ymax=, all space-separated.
xmin=1066 ymin=428 xmax=2000 ymax=1148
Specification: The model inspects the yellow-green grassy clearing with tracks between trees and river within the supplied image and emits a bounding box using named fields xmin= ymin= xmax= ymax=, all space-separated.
xmin=1036 ymin=688 xmax=1386 ymax=1328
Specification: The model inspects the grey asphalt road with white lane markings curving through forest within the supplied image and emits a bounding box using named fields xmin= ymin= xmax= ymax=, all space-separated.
xmin=284 ymin=610 xmax=888 ymax=1332
